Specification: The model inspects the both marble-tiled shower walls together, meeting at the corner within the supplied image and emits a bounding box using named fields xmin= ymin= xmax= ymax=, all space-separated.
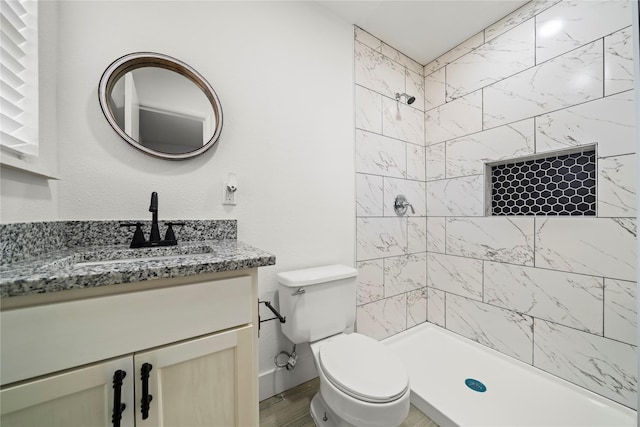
xmin=355 ymin=0 xmax=638 ymax=408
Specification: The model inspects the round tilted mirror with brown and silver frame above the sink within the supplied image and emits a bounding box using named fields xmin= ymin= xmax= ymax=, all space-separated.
xmin=98 ymin=52 xmax=222 ymax=160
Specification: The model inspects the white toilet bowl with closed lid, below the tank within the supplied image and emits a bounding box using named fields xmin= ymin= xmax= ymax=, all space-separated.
xmin=311 ymin=333 xmax=410 ymax=427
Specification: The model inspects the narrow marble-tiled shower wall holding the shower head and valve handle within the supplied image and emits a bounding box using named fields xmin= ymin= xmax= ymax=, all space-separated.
xmin=355 ymin=28 xmax=428 ymax=348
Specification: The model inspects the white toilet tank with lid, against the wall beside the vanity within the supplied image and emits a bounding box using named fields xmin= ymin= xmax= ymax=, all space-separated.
xmin=277 ymin=265 xmax=358 ymax=344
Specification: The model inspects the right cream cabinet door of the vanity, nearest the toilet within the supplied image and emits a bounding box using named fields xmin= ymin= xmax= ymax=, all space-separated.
xmin=134 ymin=325 xmax=258 ymax=427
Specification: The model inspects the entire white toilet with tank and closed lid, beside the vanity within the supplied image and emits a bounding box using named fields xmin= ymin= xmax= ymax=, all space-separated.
xmin=277 ymin=265 xmax=410 ymax=427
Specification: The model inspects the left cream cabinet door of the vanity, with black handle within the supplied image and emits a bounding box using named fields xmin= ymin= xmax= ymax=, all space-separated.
xmin=0 ymin=356 xmax=135 ymax=427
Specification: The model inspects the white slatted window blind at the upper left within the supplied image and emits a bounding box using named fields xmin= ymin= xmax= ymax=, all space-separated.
xmin=0 ymin=0 xmax=38 ymax=158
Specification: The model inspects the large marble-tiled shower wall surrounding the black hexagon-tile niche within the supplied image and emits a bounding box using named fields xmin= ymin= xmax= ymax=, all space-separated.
xmin=425 ymin=0 xmax=638 ymax=408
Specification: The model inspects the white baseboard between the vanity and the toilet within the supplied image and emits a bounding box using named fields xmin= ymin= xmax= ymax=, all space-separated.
xmin=259 ymin=352 xmax=318 ymax=401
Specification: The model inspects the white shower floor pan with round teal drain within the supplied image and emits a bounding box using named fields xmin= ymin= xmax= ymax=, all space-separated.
xmin=382 ymin=323 xmax=636 ymax=427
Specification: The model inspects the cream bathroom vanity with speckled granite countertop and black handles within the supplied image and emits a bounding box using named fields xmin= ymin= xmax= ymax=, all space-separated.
xmin=0 ymin=222 xmax=275 ymax=427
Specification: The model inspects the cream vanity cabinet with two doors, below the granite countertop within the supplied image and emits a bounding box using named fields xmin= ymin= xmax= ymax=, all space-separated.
xmin=0 ymin=269 xmax=258 ymax=427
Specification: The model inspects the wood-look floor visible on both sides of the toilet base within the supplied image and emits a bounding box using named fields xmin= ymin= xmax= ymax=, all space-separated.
xmin=260 ymin=378 xmax=438 ymax=427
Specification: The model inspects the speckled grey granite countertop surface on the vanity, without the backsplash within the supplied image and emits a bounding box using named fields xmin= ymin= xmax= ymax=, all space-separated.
xmin=0 ymin=239 xmax=275 ymax=298
